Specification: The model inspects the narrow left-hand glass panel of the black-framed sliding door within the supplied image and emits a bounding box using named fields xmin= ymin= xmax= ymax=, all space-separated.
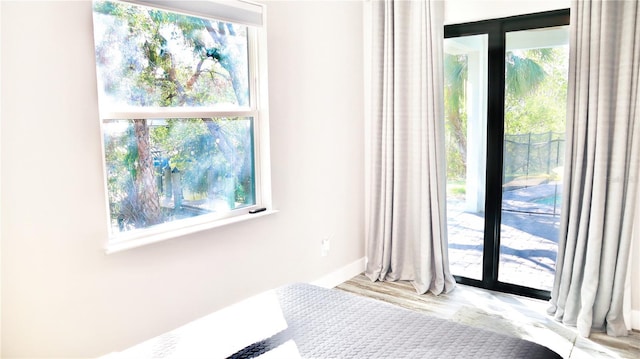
xmin=444 ymin=34 xmax=487 ymax=280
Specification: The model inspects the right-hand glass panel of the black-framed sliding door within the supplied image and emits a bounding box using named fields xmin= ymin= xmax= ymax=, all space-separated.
xmin=498 ymin=26 xmax=569 ymax=290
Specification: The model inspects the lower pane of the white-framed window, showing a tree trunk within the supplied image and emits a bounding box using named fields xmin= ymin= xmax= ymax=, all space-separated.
xmin=103 ymin=117 xmax=255 ymax=234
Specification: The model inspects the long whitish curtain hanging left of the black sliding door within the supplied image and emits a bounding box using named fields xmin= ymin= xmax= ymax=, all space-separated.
xmin=365 ymin=0 xmax=455 ymax=294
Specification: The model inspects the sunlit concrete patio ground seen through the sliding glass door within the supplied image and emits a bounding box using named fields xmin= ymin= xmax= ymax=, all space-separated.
xmin=447 ymin=184 xmax=561 ymax=290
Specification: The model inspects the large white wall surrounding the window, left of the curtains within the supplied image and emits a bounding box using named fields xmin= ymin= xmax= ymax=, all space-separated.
xmin=0 ymin=1 xmax=364 ymax=358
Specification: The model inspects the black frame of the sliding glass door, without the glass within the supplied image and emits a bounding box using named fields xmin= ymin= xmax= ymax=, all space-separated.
xmin=444 ymin=9 xmax=569 ymax=300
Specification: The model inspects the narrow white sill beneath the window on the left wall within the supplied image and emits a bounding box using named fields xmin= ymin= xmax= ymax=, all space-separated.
xmin=105 ymin=209 xmax=278 ymax=254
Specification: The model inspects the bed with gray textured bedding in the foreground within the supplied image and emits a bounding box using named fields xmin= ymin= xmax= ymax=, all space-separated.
xmin=108 ymin=284 xmax=560 ymax=358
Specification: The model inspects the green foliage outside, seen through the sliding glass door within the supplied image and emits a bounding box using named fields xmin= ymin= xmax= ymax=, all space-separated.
xmin=444 ymin=47 xmax=568 ymax=187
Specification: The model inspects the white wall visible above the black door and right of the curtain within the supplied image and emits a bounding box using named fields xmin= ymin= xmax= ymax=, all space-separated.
xmin=445 ymin=0 xmax=640 ymax=329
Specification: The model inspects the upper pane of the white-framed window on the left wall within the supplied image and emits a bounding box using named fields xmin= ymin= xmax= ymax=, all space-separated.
xmin=94 ymin=1 xmax=249 ymax=110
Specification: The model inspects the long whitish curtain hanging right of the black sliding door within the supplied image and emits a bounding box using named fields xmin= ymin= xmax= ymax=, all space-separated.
xmin=550 ymin=0 xmax=640 ymax=336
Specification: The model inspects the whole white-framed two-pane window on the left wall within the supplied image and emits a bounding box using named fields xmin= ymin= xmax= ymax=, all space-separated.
xmin=93 ymin=1 xmax=269 ymax=252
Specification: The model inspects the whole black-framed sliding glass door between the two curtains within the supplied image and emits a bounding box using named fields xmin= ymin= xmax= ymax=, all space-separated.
xmin=444 ymin=10 xmax=569 ymax=299
